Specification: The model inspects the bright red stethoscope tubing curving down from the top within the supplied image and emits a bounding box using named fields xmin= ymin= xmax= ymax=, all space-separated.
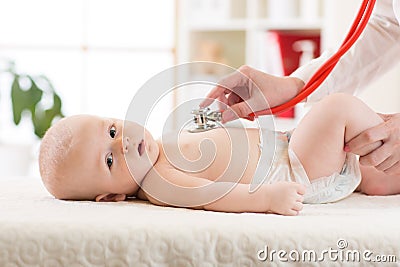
xmin=248 ymin=0 xmax=376 ymax=120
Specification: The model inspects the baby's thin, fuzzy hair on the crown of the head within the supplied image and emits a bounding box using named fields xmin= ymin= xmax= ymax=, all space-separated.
xmin=39 ymin=119 xmax=73 ymax=198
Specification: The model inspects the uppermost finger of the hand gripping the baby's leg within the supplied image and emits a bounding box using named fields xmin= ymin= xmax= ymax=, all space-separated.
xmin=346 ymin=123 xmax=388 ymax=152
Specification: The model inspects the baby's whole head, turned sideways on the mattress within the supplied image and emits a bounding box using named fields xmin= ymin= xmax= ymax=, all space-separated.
xmin=39 ymin=115 xmax=159 ymax=201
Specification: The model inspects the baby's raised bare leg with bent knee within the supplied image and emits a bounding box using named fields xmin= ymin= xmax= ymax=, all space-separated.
xmin=289 ymin=94 xmax=383 ymax=180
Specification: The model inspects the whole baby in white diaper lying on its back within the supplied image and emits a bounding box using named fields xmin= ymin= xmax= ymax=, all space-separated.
xmin=39 ymin=94 xmax=400 ymax=215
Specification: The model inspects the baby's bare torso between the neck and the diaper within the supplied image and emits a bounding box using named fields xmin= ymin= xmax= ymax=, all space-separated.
xmin=159 ymin=128 xmax=260 ymax=184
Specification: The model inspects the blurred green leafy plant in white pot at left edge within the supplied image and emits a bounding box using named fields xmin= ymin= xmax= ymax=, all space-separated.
xmin=0 ymin=61 xmax=64 ymax=175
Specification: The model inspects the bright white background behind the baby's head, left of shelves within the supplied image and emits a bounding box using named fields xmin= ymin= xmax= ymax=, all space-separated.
xmin=0 ymin=0 xmax=175 ymax=143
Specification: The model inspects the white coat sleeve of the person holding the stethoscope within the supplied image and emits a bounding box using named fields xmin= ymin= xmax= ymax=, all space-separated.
xmin=290 ymin=0 xmax=400 ymax=102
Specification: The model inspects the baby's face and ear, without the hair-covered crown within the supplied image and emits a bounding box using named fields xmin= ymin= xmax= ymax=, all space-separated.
xmin=64 ymin=115 xmax=159 ymax=200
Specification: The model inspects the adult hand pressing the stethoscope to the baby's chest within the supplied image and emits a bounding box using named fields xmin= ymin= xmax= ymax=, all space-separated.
xmin=200 ymin=66 xmax=304 ymax=123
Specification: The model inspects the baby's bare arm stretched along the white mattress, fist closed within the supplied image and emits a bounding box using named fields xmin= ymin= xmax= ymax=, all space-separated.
xmin=142 ymin=169 xmax=305 ymax=215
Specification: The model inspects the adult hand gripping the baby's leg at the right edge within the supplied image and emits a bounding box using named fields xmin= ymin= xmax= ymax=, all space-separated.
xmin=345 ymin=113 xmax=400 ymax=175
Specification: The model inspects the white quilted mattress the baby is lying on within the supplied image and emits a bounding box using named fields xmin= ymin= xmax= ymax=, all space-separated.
xmin=0 ymin=178 xmax=400 ymax=266
